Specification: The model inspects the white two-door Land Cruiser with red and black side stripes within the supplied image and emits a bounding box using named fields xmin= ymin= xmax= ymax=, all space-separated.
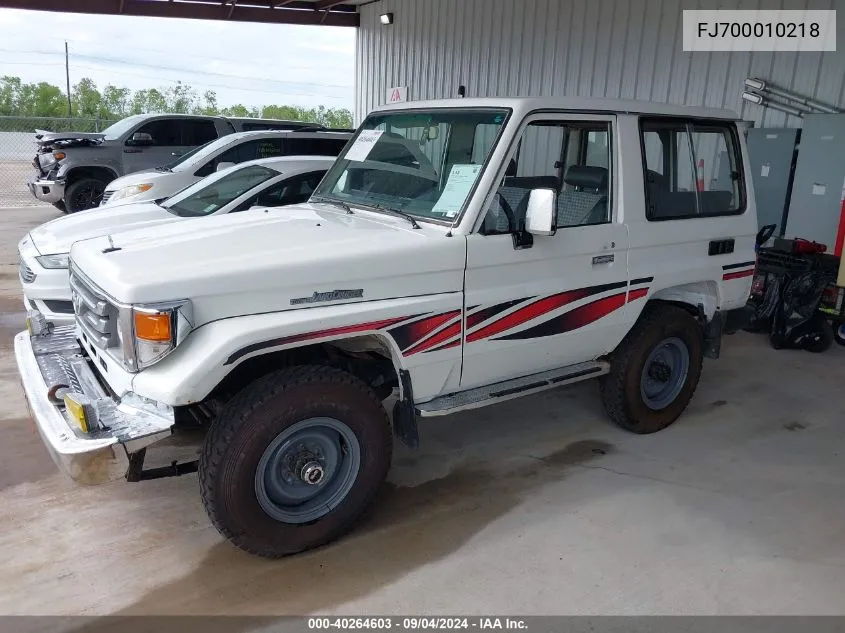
xmin=15 ymin=98 xmax=757 ymax=557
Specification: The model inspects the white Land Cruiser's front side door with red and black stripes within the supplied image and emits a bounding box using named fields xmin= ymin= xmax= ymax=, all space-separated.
xmin=461 ymin=114 xmax=628 ymax=389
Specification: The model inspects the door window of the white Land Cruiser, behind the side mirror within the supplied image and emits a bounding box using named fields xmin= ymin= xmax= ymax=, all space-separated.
xmin=482 ymin=121 xmax=612 ymax=235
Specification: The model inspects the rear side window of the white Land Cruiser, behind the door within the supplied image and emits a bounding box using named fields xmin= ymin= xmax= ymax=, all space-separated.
xmin=640 ymin=120 xmax=745 ymax=221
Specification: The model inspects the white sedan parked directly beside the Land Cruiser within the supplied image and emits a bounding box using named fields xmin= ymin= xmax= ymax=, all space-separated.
xmin=18 ymin=156 xmax=334 ymax=325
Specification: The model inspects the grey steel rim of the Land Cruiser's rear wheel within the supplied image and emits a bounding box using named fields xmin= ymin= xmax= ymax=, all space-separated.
xmin=640 ymin=337 xmax=689 ymax=411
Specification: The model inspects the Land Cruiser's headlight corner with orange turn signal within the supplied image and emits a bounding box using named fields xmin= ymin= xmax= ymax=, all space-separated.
xmin=117 ymin=301 xmax=193 ymax=371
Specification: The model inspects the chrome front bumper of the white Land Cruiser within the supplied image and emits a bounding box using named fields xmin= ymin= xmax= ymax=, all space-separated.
xmin=15 ymin=326 xmax=173 ymax=484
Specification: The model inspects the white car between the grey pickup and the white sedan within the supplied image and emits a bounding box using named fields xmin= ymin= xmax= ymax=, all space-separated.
xmin=100 ymin=130 xmax=352 ymax=207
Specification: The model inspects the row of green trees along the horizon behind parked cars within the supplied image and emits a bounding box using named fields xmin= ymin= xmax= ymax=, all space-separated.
xmin=0 ymin=76 xmax=352 ymax=131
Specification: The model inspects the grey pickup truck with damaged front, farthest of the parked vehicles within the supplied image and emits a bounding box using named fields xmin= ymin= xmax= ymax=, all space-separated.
xmin=27 ymin=114 xmax=342 ymax=213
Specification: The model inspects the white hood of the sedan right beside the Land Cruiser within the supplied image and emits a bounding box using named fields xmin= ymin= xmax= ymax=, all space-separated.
xmin=29 ymin=202 xmax=185 ymax=255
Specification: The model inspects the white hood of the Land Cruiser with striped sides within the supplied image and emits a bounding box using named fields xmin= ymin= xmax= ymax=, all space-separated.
xmin=71 ymin=204 xmax=466 ymax=325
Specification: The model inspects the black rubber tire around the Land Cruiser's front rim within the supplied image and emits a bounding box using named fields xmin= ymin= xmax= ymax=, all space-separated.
xmin=198 ymin=366 xmax=393 ymax=558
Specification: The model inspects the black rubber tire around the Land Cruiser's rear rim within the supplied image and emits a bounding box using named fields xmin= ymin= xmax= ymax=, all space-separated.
xmin=601 ymin=303 xmax=704 ymax=435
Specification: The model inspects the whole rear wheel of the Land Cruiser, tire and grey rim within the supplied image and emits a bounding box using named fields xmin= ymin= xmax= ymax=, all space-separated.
xmin=601 ymin=304 xmax=704 ymax=434
